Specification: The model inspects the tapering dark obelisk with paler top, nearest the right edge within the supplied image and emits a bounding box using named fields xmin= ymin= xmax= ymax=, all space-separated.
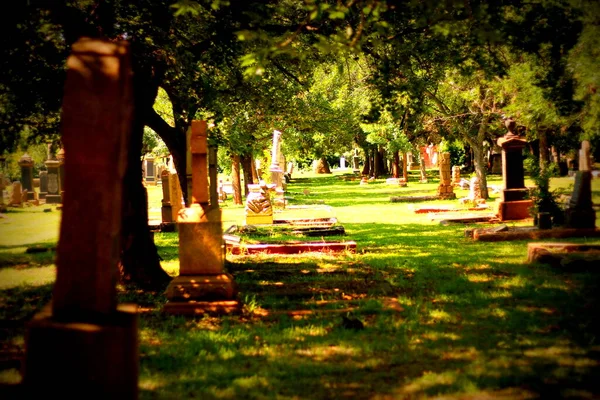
xmin=565 ymin=140 xmax=596 ymax=229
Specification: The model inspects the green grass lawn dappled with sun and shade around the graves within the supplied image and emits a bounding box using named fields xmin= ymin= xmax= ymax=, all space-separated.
xmin=0 ymin=171 xmax=600 ymax=399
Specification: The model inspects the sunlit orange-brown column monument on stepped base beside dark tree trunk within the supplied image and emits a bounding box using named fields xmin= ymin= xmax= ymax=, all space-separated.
xmin=164 ymin=121 xmax=239 ymax=315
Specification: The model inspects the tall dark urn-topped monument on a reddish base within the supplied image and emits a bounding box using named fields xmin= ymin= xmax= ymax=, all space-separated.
xmin=498 ymin=118 xmax=532 ymax=221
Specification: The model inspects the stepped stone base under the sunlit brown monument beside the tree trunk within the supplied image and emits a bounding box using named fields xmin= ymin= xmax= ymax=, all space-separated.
xmin=163 ymin=273 xmax=239 ymax=315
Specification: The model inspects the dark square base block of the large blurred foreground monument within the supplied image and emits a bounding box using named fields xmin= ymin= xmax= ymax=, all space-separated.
xmin=22 ymin=304 xmax=139 ymax=399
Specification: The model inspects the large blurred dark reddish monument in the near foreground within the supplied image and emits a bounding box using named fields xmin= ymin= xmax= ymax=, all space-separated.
xmin=23 ymin=38 xmax=139 ymax=399
